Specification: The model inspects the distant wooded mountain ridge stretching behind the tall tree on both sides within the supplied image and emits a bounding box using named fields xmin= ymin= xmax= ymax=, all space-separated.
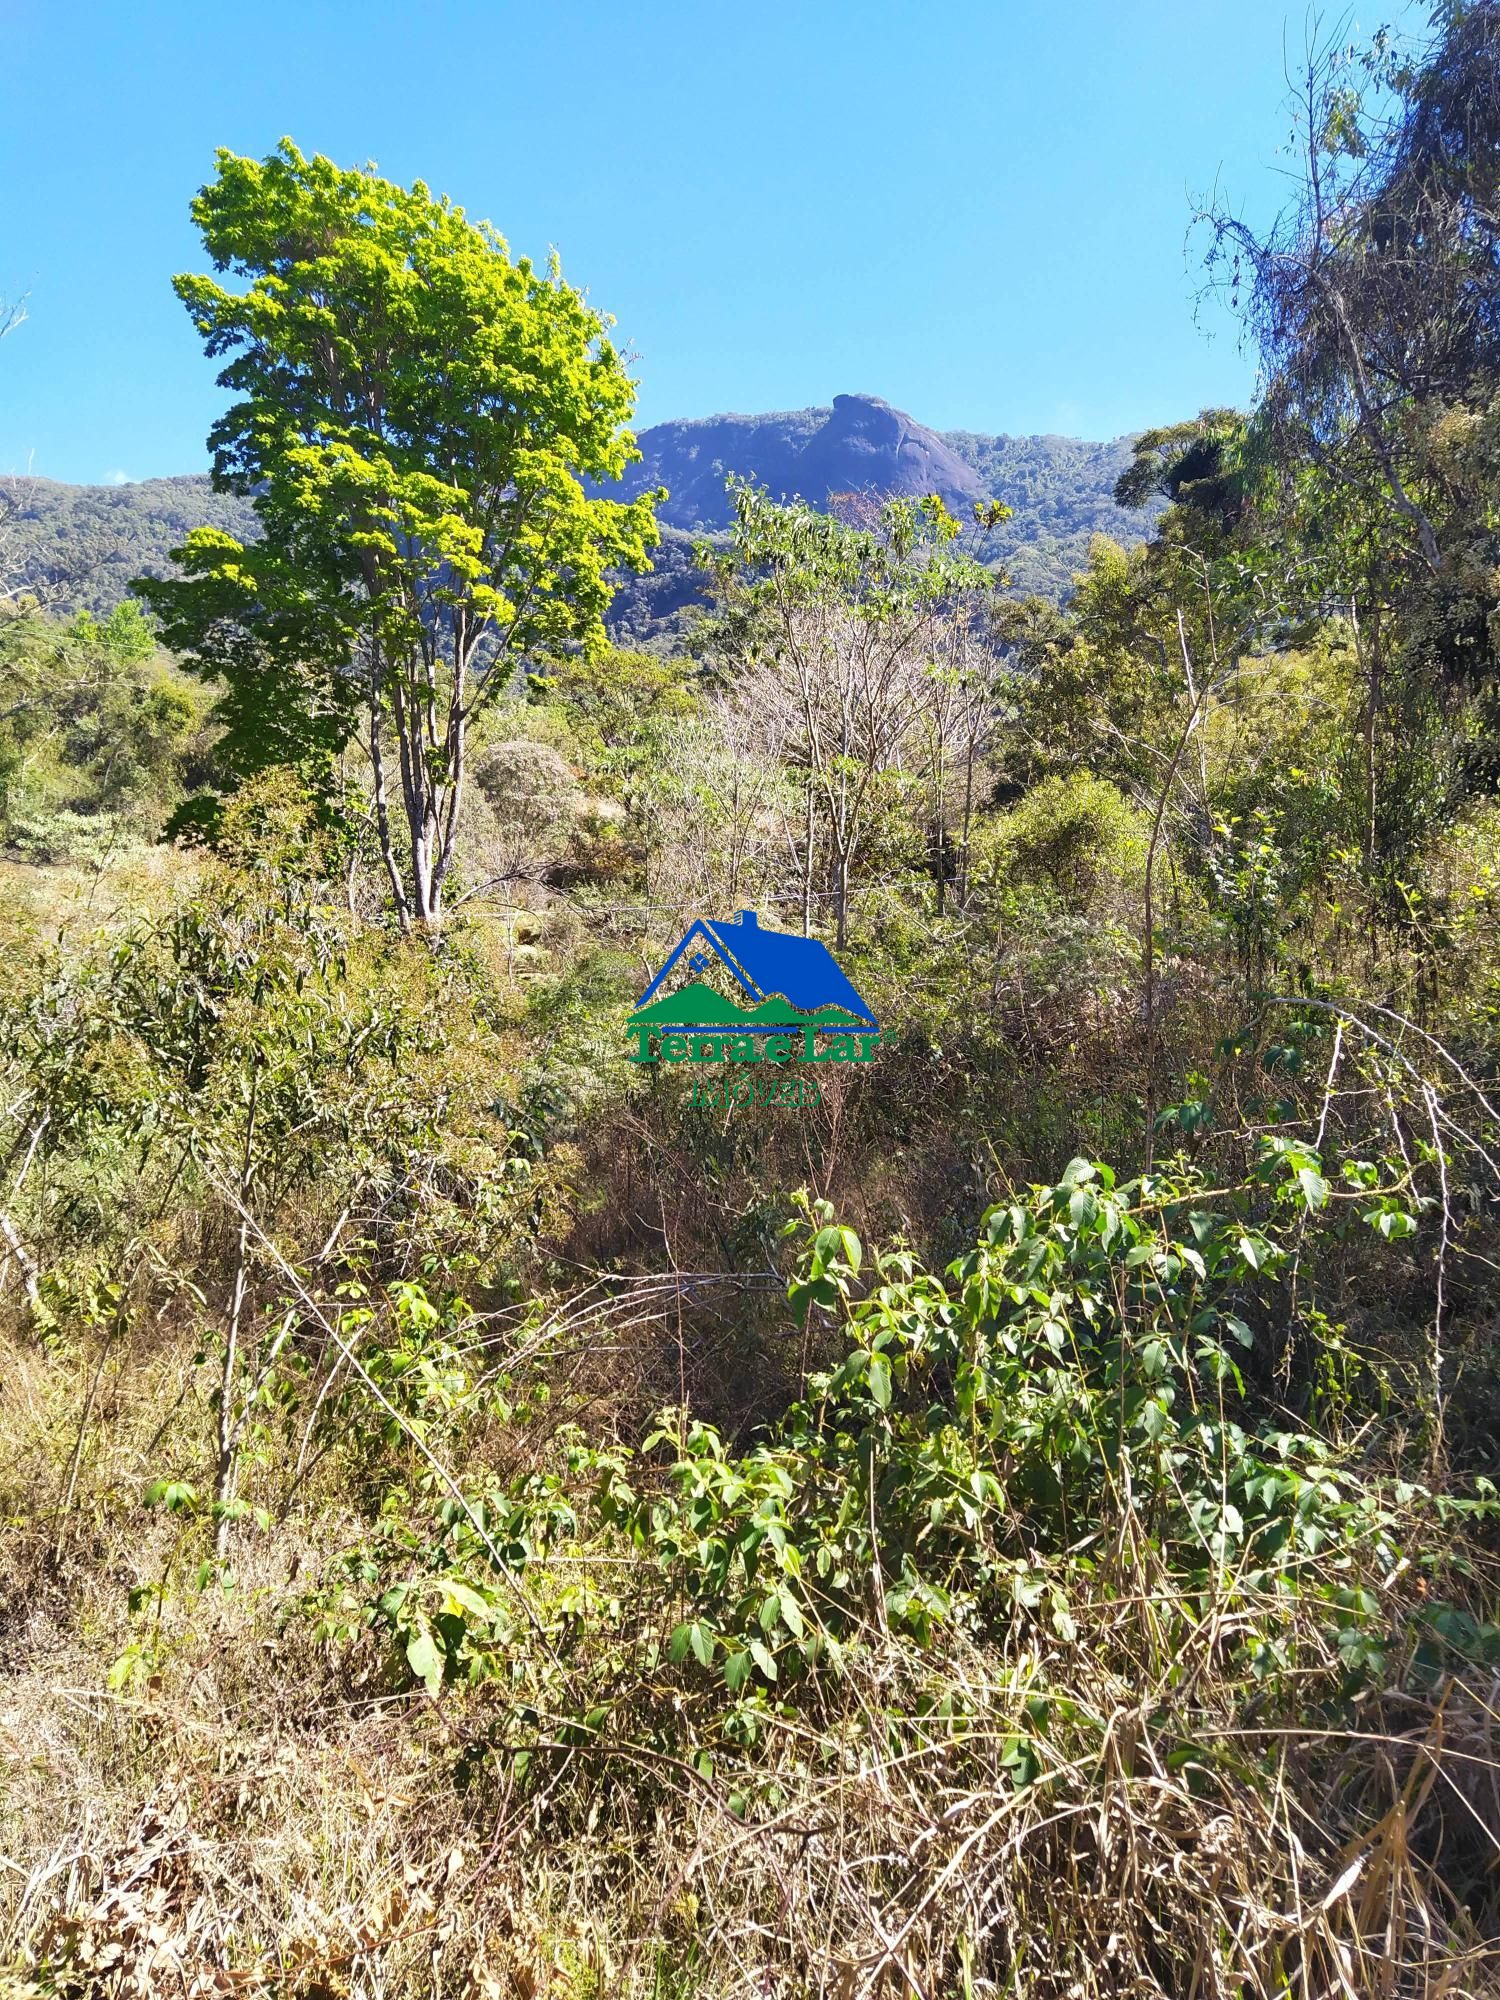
xmin=0 ymin=396 xmax=1150 ymax=644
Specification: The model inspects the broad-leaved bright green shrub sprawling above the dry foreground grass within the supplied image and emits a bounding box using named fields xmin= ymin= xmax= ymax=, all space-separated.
xmin=290 ymin=1146 xmax=1500 ymax=1736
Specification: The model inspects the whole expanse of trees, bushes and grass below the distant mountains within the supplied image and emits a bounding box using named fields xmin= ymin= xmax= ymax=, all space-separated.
xmin=0 ymin=0 xmax=1500 ymax=2000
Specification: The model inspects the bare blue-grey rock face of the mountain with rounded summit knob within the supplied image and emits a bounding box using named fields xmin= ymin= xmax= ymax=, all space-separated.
xmin=624 ymin=396 xmax=1000 ymax=530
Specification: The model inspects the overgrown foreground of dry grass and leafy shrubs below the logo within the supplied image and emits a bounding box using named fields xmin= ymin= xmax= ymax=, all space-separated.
xmin=2 ymin=824 xmax=1500 ymax=1994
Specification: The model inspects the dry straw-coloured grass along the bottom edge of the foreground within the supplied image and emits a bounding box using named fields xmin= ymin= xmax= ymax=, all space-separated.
xmin=0 ymin=1304 xmax=1500 ymax=2000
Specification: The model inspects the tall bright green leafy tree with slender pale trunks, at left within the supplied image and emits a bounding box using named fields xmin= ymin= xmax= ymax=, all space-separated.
xmin=138 ymin=140 xmax=656 ymax=930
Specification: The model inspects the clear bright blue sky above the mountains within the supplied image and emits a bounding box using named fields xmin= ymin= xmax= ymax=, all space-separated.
xmin=0 ymin=0 xmax=1424 ymax=480
